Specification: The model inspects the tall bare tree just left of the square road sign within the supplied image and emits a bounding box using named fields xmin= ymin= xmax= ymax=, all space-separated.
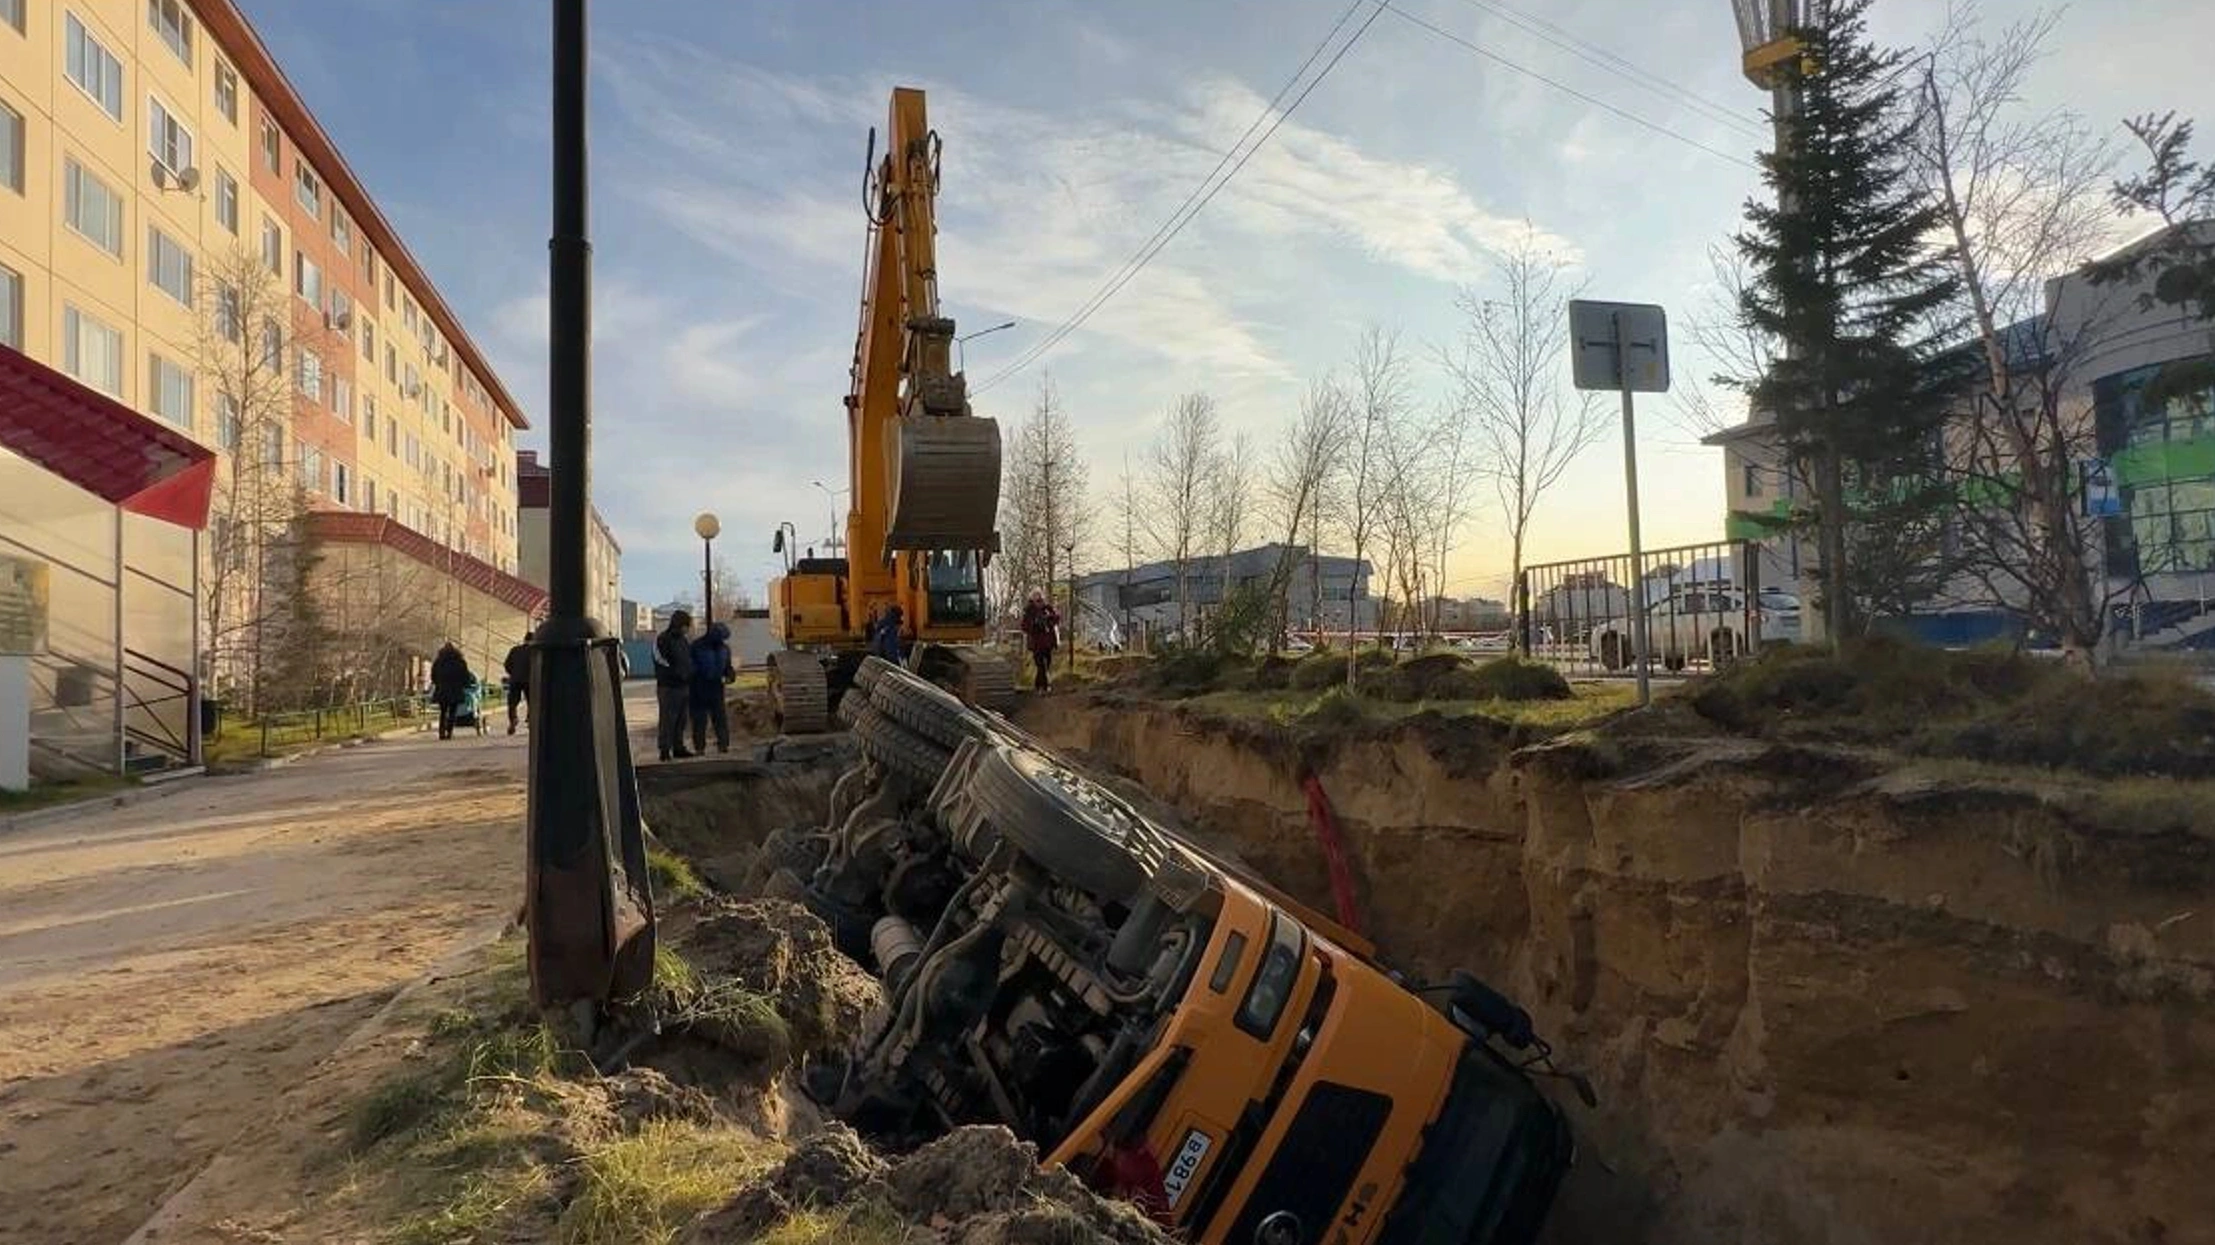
xmin=1449 ymin=230 xmax=1606 ymax=615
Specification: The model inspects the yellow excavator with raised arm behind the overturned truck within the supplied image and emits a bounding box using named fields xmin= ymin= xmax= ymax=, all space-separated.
xmin=769 ymin=86 xmax=1014 ymax=733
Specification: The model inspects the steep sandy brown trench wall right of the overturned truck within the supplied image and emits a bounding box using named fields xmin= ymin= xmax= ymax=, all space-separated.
xmin=1026 ymin=698 xmax=2215 ymax=1245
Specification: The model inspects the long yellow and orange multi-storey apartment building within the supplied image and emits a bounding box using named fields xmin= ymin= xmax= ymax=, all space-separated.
xmin=0 ymin=0 xmax=529 ymax=700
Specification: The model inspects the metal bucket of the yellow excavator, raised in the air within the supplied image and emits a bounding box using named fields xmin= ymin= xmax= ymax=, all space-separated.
xmin=884 ymin=414 xmax=999 ymax=552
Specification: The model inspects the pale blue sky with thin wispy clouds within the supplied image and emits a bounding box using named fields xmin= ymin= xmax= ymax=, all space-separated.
xmin=241 ymin=0 xmax=2215 ymax=603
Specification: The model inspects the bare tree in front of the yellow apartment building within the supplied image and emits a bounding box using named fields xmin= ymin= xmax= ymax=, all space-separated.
xmin=193 ymin=248 xmax=328 ymax=713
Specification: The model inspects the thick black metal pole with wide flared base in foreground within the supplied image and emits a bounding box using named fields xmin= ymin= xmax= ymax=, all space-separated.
xmin=523 ymin=0 xmax=653 ymax=1027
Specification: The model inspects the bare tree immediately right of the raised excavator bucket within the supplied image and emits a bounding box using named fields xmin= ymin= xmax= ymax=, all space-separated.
xmin=997 ymin=367 xmax=1092 ymax=627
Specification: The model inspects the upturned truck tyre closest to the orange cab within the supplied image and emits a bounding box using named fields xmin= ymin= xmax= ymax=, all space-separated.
xmin=970 ymin=749 xmax=1165 ymax=904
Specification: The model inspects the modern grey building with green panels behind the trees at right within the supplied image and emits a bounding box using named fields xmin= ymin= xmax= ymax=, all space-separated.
xmin=1708 ymin=222 xmax=2215 ymax=647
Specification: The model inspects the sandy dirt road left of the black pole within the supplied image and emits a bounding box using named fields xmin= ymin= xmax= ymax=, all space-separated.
xmin=0 ymin=722 xmax=525 ymax=1245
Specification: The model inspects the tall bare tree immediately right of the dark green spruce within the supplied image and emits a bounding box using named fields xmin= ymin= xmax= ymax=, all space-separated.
xmin=1916 ymin=4 xmax=2115 ymax=669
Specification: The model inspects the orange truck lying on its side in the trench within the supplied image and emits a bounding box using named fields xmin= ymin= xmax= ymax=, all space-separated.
xmin=769 ymin=658 xmax=1573 ymax=1245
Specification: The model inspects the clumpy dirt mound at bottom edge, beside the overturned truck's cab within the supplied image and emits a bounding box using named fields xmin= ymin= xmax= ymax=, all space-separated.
xmin=684 ymin=1125 xmax=1167 ymax=1245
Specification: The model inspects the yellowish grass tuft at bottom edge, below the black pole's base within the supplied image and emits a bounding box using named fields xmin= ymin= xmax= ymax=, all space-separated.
xmin=560 ymin=1119 xmax=777 ymax=1245
